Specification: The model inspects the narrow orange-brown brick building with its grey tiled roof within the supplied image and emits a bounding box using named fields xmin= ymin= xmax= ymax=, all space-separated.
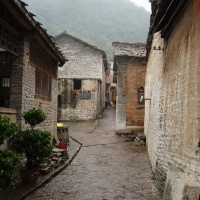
xmin=112 ymin=42 xmax=145 ymax=132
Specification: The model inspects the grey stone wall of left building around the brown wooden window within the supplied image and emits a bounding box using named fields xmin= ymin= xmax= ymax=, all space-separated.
xmin=11 ymin=39 xmax=57 ymax=134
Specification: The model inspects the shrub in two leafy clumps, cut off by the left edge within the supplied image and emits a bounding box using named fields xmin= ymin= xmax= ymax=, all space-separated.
xmin=0 ymin=116 xmax=21 ymax=192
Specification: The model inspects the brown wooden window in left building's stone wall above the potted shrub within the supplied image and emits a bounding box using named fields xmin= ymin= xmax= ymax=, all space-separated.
xmin=35 ymin=70 xmax=51 ymax=100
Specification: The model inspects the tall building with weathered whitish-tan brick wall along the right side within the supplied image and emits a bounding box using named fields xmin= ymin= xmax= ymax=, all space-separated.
xmin=145 ymin=0 xmax=200 ymax=200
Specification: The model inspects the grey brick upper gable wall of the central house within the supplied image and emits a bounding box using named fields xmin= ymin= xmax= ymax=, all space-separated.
xmin=56 ymin=36 xmax=103 ymax=80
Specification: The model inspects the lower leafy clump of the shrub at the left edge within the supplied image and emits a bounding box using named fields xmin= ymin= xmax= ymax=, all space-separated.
xmin=0 ymin=150 xmax=21 ymax=191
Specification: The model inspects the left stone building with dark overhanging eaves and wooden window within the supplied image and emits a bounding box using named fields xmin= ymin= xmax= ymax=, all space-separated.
xmin=0 ymin=0 xmax=65 ymax=145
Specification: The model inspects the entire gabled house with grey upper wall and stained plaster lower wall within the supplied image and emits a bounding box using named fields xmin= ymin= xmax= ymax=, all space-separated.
xmin=54 ymin=32 xmax=107 ymax=121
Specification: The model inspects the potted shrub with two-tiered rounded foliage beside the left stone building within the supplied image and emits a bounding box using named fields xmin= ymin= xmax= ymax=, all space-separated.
xmin=12 ymin=108 xmax=52 ymax=182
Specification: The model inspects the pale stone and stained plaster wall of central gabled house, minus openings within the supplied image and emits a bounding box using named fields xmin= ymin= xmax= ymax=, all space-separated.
xmin=56 ymin=35 xmax=105 ymax=121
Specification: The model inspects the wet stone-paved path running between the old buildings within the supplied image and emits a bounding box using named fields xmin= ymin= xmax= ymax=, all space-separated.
xmin=26 ymin=108 xmax=161 ymax=200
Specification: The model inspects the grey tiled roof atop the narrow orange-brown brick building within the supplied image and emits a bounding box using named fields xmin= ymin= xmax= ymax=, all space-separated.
xmin=112 ymin=42 xmax=146 ymax=57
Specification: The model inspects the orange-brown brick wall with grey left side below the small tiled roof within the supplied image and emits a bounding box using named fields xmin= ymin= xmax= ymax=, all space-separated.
xmin=116 ymin=58 xmax=145 ymax=130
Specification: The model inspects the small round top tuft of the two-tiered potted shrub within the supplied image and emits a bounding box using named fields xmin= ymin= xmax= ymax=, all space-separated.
xmin=22 ymin=108 xmax=47 ymax=128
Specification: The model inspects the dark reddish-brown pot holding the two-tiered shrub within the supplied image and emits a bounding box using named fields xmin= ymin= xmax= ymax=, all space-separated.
xmin=20 ymin=169 xmax=39 ymax=183
